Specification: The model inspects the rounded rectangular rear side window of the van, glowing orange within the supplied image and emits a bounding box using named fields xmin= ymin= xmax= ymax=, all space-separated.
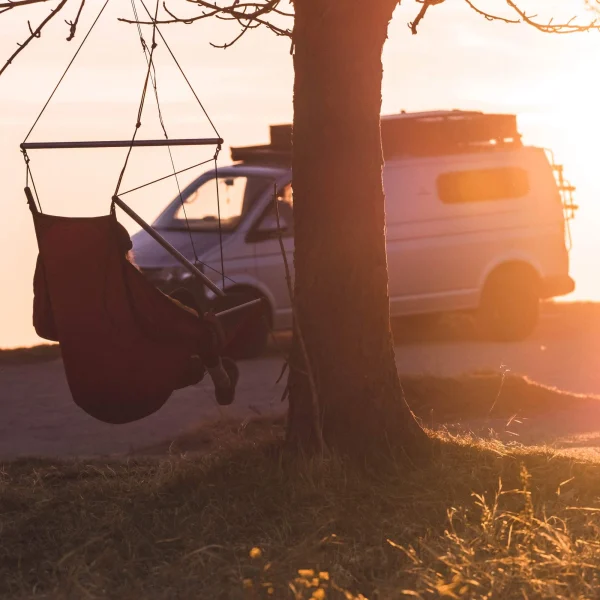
xmin=437 ymin=167 xmax=529 ymax=204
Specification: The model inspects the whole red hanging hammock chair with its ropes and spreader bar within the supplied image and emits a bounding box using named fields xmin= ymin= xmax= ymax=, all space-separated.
xmin=21 ymin=0 xmax=262 ymax=424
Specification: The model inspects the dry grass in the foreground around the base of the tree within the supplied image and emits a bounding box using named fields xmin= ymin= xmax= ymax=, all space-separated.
xmin=0 ymin=428 xmax=600 ymax=600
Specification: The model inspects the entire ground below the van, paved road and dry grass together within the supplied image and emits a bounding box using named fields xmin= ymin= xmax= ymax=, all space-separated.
xmin=0 ymin=306 xmax=600 ymax=600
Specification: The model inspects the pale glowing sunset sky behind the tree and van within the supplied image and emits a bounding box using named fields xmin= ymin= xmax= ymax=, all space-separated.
xmin=0 ymin=0 xmax=600 ymax=347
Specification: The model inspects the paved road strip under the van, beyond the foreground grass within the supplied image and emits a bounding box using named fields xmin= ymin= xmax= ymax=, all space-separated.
xmin=0 ymin=305 xmax=600 ymax=458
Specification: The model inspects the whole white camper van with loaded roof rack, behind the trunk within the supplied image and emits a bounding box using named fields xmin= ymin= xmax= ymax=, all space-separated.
xmin=134 ymin=111 xmax=576 ymax=356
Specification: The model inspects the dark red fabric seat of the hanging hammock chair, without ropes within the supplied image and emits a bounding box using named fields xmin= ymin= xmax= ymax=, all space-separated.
xmin=30 ymin=205 xmax=253 ymax=423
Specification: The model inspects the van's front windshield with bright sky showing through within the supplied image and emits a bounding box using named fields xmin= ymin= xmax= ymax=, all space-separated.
xmin=171 ymin=175 xmax=271 ymax=231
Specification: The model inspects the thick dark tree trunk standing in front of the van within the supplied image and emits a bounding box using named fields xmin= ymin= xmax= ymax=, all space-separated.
xmin=287 ymin=0 xmax=430 ymax=459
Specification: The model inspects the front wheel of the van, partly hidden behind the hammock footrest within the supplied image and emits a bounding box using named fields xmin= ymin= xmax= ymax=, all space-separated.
xmin=213 ymin=289 xmax=271 ymax=360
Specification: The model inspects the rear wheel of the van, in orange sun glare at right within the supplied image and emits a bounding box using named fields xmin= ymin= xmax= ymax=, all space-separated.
xmin=478 ymin=271 xmax=540 ymax=342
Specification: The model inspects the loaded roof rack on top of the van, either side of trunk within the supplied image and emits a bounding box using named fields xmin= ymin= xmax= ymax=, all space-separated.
xmin=231 ymin=110 xmax=522 ymax=166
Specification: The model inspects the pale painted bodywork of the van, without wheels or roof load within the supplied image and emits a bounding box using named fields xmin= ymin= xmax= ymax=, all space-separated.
xmin=134 ymin=138 xmax=573 ymax=329
